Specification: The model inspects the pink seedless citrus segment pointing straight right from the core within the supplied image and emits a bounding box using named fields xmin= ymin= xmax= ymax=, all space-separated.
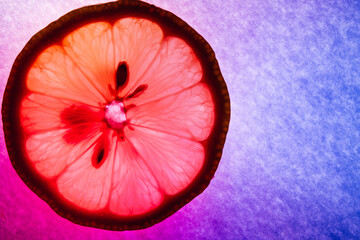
xmin=127 ymin=83 xmax=214 ymax=141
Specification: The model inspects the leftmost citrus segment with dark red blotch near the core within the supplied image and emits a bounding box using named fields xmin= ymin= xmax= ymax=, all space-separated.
xmin=21 ymin=93 xmax=106 ymax=140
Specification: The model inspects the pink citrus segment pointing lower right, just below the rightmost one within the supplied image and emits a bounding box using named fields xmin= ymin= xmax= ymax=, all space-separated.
xmin=125 ymin=126 xmax=205 ymax=195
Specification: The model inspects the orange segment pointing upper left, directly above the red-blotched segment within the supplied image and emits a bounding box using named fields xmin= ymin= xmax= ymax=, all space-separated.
xmin=26 ymin=45 xmax=105 ymax=106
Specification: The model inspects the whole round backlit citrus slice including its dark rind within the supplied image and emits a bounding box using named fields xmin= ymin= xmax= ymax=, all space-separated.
xmin=2 ymin=1 xmax=230 ymax=230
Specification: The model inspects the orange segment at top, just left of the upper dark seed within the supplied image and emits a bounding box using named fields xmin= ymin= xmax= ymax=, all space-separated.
xmin=62 ymin=22 xmax=117 ymax=101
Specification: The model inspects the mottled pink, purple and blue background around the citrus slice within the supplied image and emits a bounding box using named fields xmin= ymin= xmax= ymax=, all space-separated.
xmin=0 ymin=0 xmax=360 ymax=239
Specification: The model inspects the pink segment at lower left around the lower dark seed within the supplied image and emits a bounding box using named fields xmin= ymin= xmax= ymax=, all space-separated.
xmin=57 ymin=130 xmax=117 ymax=210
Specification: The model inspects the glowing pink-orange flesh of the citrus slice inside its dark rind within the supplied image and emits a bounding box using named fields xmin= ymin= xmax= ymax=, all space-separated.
xmin=21 ymin=18 xmax=214 ymax=216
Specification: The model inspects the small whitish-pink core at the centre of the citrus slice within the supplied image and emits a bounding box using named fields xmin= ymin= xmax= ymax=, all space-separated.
xmin=105 ymin=101 xmax=126 ymax=129
